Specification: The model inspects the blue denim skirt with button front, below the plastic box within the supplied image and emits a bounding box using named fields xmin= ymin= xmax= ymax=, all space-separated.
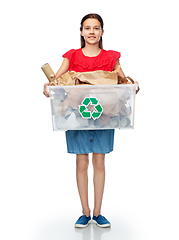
xmin=66 ymin=129 xmax=114 ymax=154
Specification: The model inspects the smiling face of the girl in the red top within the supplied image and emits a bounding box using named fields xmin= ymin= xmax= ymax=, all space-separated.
xmin=81 ymin=18 xmax=104 ymax=45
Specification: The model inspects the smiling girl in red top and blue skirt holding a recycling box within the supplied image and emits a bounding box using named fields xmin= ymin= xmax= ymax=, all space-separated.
xmin=44 ymin=14 xmax=139 ymax=227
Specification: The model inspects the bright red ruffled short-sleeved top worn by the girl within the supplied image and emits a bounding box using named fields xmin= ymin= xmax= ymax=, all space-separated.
xmin=63 ymin=48 xmax=121 ymax=72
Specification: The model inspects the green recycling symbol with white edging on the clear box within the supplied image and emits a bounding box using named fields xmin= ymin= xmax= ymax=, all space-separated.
xmin=79 ymin=97 xmax=103 ymax=120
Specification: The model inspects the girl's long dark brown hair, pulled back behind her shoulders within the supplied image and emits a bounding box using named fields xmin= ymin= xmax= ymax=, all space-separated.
xmin=80 ymin=13 xmax=104 ymax=49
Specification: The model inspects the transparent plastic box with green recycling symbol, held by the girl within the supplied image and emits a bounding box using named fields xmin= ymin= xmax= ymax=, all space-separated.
xmin=49 ymin=84 xmax=137 ymax=131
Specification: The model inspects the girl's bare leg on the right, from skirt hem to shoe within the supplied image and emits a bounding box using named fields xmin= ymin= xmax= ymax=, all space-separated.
xmin=92 ymin=153 xmax=105 ymax=217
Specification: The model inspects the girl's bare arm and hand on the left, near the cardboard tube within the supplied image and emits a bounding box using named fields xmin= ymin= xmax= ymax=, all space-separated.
xmin=43 ymin=58 xmax=70 ymax=97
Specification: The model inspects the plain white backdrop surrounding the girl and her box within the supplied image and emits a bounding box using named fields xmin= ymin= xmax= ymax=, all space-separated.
xmin=0 ymin=0 xmax=179 ymax=240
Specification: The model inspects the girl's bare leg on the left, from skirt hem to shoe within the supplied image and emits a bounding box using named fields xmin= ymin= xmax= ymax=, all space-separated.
xmin=76 ymin=154 xmax=90 ymax=217
